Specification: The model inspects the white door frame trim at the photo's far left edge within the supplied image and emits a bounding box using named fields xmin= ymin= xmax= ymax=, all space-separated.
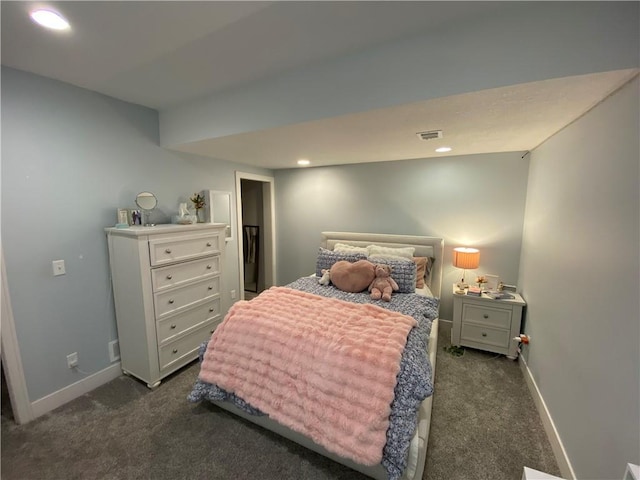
xmin=0 ymin=251 xmax=35 ymax=424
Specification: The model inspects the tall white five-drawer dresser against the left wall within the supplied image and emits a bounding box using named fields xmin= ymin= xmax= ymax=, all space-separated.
xmin=106 ymin=223 xmax=225 ymax=388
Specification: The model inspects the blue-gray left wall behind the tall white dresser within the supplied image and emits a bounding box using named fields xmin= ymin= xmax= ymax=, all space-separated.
xmin=2 ymin=67 xmax=270 ymax=401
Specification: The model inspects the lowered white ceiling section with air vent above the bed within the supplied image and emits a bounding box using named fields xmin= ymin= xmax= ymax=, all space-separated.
xmin=172 ymin=70 xmax=636 ymax=168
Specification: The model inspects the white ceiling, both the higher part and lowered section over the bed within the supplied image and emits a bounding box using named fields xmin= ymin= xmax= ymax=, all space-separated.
xmin=0 ymin=1 xmax=637 ymax=168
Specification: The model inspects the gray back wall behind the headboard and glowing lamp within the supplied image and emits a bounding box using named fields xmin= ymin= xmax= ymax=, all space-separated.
xmin=275 ymin=153 xmax=528 ymax=320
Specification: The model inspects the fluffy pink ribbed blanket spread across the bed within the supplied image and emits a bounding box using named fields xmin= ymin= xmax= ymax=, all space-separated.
xmin=200 ymin=287 xmax=417 ymax=465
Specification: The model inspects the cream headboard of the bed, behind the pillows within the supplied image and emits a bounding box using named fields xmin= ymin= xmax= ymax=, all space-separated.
xmin=320 ymin=232 xmax=444 ymax=297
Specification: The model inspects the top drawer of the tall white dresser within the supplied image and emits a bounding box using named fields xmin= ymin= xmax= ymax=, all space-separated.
xmin=149 ymin=233 xmax=224 ymax=266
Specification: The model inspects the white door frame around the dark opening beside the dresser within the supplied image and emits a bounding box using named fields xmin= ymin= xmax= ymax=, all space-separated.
xmin=236 ymin=171 xmax=276 ymax=300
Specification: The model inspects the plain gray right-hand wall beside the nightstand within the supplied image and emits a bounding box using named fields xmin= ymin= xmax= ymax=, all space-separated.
xmin=520 ymin=77 xmax=640 ymax=479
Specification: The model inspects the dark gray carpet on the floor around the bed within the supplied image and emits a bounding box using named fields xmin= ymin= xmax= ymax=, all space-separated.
xmin=1 ymin=325 xmax=559 ymax=480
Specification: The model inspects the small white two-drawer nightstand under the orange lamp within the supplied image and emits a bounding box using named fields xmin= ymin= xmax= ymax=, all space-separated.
xmin=451 ymin=285 xmax=526 ymax=360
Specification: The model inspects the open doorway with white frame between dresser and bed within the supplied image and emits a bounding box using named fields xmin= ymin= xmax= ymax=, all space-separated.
xmin=236 ymin=172 xmax=276 ymax=300
